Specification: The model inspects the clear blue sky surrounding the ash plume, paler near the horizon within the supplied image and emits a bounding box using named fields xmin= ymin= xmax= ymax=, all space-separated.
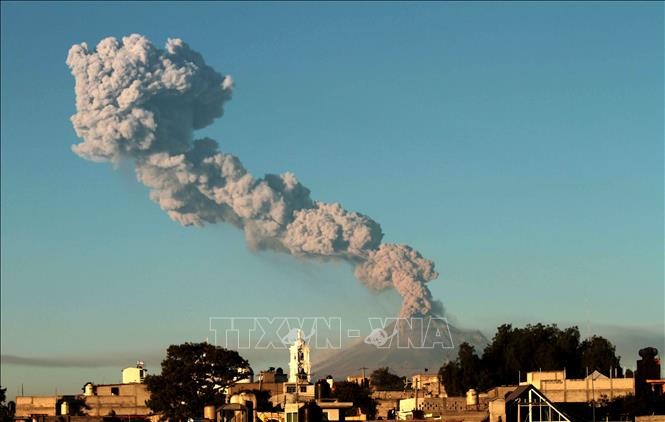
xmin=1 ymin=2 xmax=665 ymax=396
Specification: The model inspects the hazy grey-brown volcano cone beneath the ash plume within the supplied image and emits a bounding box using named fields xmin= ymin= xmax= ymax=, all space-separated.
xmin=312 ymin=317 xmax=488 ymax=378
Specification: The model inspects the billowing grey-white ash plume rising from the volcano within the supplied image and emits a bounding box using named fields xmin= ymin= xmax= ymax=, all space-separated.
xmin=67 ymin=34 xmax=442 ymax=317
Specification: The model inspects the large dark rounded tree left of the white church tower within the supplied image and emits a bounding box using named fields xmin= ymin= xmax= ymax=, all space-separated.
xmin=145 ymin=343 xmax=251 ymax=421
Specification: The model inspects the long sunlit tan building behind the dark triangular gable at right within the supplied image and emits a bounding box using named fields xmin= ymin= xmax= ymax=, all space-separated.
xmin=520 ymin=370 xmax=635 ymax=403
